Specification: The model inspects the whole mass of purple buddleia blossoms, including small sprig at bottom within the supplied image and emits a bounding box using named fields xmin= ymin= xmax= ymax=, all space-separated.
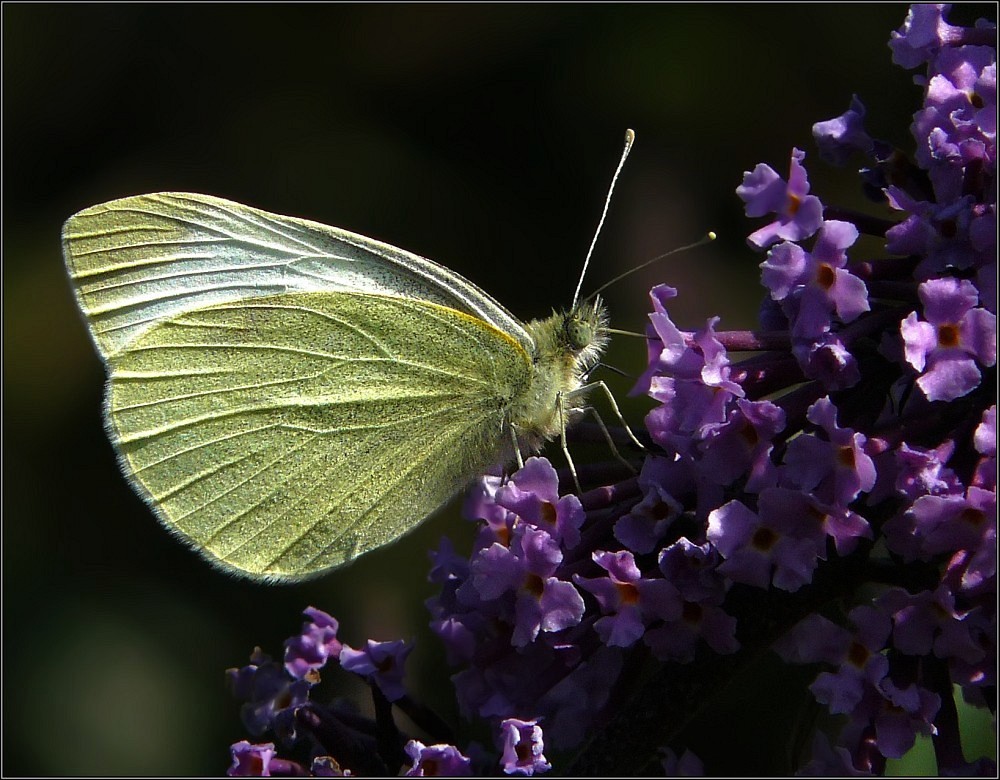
xmin=230 ymin=5 xmax=997 ymax=776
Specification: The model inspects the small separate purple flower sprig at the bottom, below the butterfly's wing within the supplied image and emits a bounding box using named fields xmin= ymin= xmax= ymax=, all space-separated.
xmin=226 ymin=607 xmax=532 ymax=777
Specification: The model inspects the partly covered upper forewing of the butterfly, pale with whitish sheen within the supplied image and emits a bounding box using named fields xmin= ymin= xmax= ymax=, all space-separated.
xmin=63 ymin=192 xmax=531 ymax=359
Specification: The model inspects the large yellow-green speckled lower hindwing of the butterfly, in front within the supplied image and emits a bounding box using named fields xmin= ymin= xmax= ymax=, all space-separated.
xmin=107 ymin=292 xmax=530 ymax=580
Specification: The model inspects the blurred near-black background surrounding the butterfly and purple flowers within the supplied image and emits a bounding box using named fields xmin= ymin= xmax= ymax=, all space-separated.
xmin=3 ymin=4 xmax=995 ymax=775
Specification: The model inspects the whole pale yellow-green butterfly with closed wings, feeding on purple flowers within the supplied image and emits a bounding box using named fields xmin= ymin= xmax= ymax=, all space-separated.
xmin=63 ymin=152 xmax=641 ymax=582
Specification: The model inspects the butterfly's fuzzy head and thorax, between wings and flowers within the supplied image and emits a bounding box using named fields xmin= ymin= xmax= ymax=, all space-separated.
xmin=510 ymin=299 xmax=608 ymax=449
